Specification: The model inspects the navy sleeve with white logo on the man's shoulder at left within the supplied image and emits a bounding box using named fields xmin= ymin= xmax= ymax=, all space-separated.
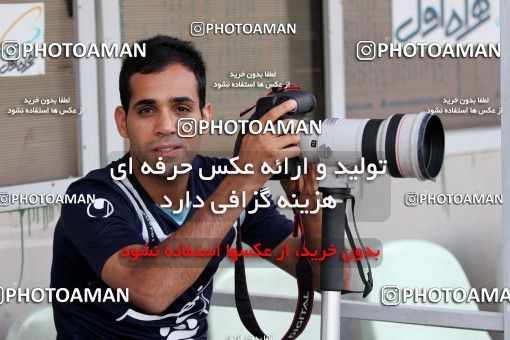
xmin=60 ymin=181 xmax=145 ymax=277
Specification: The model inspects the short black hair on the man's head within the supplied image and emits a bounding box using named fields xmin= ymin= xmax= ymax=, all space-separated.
xmin=119 ymin=35 xmax=206 ymax=114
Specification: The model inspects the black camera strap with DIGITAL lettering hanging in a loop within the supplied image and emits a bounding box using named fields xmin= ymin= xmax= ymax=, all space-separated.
xmin=234 ymin=182 xmax=314 ymax=340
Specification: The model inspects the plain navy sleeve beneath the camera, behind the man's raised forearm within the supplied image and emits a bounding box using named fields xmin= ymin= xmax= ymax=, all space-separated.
xmin=242 ymin=187 xmax=294 ymax=250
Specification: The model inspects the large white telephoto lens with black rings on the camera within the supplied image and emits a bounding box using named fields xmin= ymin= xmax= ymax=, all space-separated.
xmin=300 ymin=112 xmax=444 ymax=180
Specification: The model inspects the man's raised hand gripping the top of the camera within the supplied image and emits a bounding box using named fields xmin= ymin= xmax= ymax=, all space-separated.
xmin=236 ymin=99 xmax=301 ymax=187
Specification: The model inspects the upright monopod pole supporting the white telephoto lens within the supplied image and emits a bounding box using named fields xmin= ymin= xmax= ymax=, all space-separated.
xmin=319 ymin=187 xmax=349 ymax=340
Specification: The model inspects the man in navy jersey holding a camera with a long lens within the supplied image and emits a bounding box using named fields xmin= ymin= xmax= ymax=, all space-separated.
xmin=51 ymin=36 xmax=342 ymax=339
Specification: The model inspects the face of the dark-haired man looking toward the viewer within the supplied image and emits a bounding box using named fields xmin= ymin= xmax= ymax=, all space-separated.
xmin=115 ymin=64 xmax=211 ymax=176
